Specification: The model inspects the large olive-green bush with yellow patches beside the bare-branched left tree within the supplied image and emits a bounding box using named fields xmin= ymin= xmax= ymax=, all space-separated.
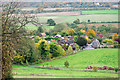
xmin=14 ymin=38 xmax=39 ymax=64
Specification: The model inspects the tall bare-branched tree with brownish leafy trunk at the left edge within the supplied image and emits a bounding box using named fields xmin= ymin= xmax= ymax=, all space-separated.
xmin=2 ymin=2 xmax=38 ymax=80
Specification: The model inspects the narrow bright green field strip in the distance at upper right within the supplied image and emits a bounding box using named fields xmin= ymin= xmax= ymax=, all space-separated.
xmin=82 ymin=10 xmax=118 ymax=14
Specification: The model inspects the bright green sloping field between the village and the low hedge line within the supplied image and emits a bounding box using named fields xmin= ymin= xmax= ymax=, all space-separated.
xmin=32 ymin=49 xmax=118 ymax=69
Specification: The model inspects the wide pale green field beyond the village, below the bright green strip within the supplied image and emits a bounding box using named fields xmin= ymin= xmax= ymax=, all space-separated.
xmin=38 ymin=14 xmax=118 ymax=23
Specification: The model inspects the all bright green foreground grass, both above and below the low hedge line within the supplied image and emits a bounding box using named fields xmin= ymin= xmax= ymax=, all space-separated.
xmin=13 ymin=49 xmax=118 ymax=78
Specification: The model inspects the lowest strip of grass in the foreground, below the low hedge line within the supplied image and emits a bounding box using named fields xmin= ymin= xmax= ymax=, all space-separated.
xmin=13 ymin=67 xmax=118 ymax=78
